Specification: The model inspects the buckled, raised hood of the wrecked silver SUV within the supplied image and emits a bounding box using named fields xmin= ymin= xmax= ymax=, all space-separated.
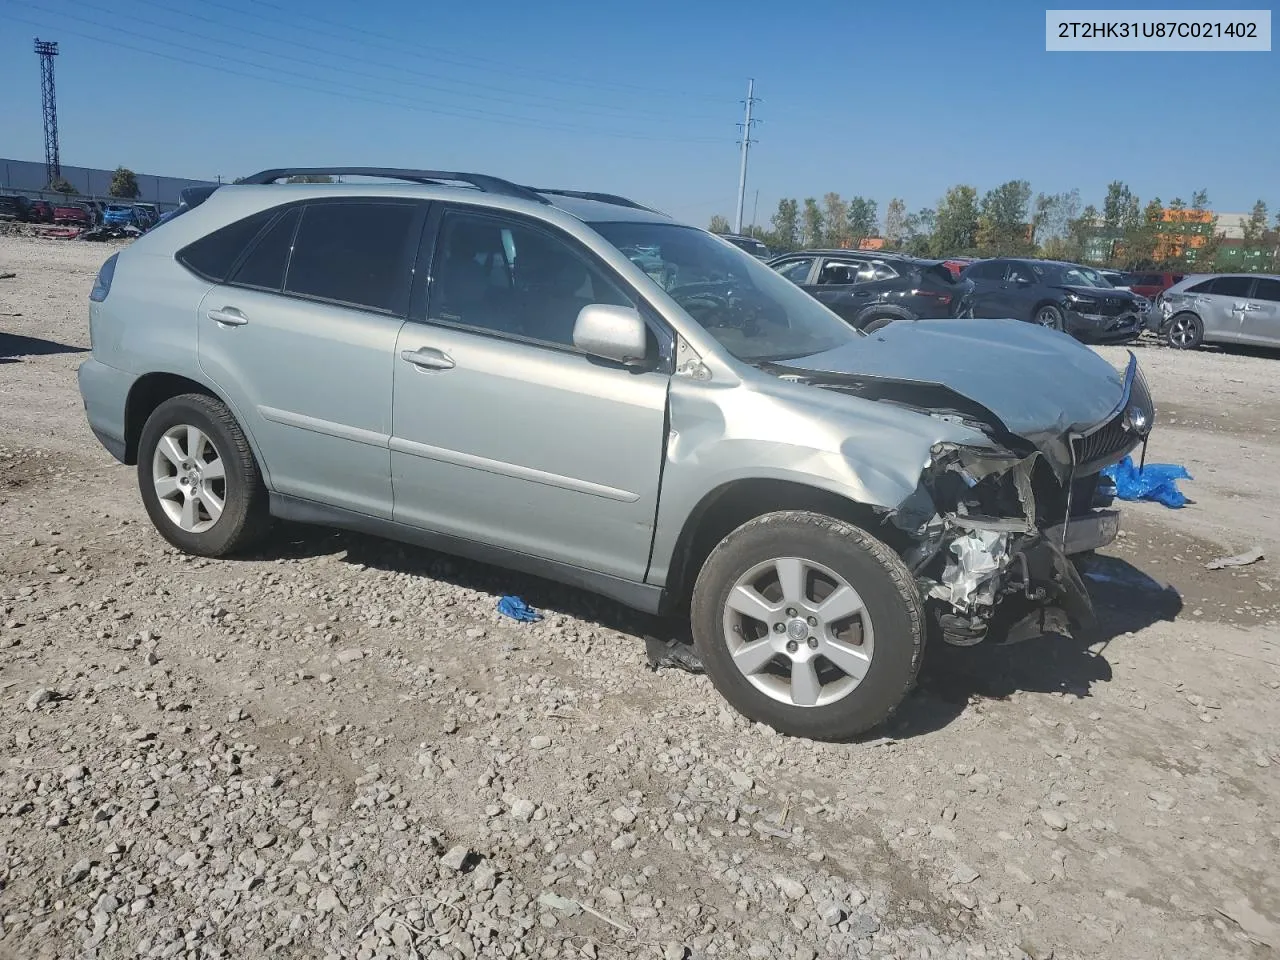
xmin=773 ymin=320 xmax=1124 ymax=449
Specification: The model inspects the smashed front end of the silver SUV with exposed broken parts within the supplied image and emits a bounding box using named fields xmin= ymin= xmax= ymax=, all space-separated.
xmin=895 ymin=353 xmax=1155 ymax=646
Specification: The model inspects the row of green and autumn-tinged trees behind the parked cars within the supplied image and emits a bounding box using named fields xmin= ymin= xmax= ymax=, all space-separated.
xmin=710 ymin=180 xmax=1280 ymax=270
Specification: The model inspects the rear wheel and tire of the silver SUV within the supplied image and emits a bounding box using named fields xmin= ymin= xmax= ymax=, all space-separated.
xmin=138 ymin=393 xmax=271 ymax=557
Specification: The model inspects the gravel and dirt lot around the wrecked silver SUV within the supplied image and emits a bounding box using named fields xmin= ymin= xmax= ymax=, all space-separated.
xmin=0 ymin=237 xmax=1280 ymax=960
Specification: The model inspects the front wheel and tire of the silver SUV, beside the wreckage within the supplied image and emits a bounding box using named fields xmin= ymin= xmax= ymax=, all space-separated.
xmin=690 ymin=511 xmax=924 ymax=740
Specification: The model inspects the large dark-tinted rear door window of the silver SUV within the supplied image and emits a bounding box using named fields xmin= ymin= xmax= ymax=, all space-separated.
xmin=284 ymin=200 xmax=425 ymax=315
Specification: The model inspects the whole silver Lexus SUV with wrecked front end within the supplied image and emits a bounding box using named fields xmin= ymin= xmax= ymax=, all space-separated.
xmin=79 ymin=168 xmax=1155 ymax=739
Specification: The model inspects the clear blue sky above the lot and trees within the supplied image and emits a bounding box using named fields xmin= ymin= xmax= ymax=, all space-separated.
xmin=0 ymin=0 xmax=1280 ymax=224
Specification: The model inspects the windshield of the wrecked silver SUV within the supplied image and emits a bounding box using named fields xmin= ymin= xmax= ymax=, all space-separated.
xmin=591 ymin=223 xmax=860 ymax=364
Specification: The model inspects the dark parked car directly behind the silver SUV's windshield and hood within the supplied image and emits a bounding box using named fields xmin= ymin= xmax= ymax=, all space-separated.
xmin=769 ymin=250 xmax=973 ymax=333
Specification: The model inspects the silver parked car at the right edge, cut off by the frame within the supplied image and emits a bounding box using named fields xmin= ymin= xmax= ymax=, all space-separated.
xmin=1156 ymin=274 xmax=1280 ymax=349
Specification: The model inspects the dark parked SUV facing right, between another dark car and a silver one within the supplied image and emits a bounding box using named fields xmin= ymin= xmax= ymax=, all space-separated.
xmin=961 ymin=257 xmax=1151 ymax=343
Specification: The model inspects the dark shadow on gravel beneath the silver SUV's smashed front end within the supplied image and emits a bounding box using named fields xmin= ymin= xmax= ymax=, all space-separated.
xmin=883 ymin=556 xmax=1183 ymax=740
